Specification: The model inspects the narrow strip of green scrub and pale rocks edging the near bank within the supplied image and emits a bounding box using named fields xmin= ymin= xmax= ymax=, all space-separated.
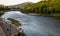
xmin=8 ymin=18 xmax=26 ymax=36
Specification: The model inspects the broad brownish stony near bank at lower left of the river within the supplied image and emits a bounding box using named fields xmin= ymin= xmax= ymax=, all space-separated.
xmin=0 ymin=17 xmax=26 ymax=36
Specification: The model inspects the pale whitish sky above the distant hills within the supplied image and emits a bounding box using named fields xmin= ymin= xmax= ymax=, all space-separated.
xmin=0 ymin=0 xmax=41 ymax=5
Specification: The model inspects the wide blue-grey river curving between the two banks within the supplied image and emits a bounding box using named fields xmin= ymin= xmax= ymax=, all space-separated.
xmin=2 ymin=11 xmax=60 ymax=36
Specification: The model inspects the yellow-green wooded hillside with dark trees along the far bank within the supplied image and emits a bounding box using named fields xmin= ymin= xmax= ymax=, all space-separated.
xmin=20 ymin=0 xmax=60 ymax=17
